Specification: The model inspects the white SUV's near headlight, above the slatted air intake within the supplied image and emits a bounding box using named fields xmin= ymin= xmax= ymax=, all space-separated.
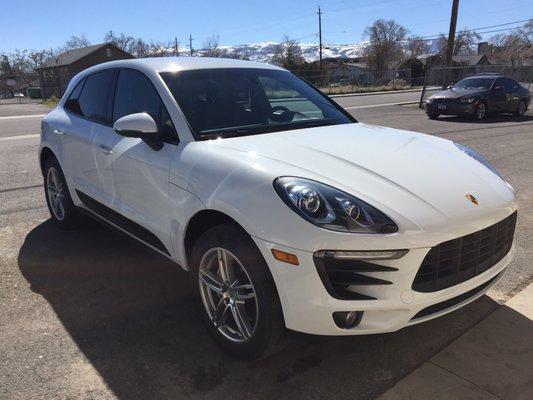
xmin=274 ymin=177 xmax=398 ymax=233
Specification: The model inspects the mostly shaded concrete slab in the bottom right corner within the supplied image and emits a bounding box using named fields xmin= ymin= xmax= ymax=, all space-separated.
xmin=378 ymin=283 xmax=533 ymax=400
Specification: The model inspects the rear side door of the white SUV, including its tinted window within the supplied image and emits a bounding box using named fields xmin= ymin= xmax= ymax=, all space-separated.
xmin=60 ymin=71 xmax=114 ymax=199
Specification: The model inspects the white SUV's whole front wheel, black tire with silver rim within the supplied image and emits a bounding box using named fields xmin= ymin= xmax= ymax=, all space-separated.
xmin=190 ymin=223 xmax=285 ymax=359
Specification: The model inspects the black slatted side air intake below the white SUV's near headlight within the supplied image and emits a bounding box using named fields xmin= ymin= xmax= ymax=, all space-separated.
xmin=313 ymin=251 xmax=398 ymax=300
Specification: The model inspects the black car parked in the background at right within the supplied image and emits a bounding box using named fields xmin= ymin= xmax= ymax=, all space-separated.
xmin=426 ymin=74 xmax=531 ymax=120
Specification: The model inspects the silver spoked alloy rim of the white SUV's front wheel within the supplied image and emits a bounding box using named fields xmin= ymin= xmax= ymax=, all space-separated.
xmin=198 ymin=247 xmax=259 ymax=343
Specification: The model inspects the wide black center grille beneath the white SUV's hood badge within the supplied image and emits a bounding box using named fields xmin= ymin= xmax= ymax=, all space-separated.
xmin=412 ymin=212 xmax=516 ymax=293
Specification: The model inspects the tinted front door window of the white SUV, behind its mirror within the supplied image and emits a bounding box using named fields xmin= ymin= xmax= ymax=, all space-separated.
xmin=113 ymin=70 xmax=177 ymax=142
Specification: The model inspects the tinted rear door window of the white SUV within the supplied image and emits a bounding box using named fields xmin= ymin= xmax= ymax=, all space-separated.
xmin=79 ymin=71 xmax=114 ymax=123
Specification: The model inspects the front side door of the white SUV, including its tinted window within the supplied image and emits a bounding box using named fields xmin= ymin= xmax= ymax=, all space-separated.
xmin=93 ymin=69 xmax=178 ymax=253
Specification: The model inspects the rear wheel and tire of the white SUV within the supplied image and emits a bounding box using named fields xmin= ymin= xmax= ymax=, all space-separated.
xmin=44 ymin=157 xmax=83 ymax=229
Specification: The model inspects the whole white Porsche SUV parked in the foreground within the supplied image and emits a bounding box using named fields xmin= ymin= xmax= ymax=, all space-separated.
xmin=39 ymin=58 xmax=517 ymax=357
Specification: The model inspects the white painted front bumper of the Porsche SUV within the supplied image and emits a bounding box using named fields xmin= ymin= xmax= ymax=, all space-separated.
xmin=254 ymin=211 xmax=514 ymax=335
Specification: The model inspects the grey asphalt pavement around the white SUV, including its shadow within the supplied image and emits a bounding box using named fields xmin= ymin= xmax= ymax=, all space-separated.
xmin=0 ymin=93 xmax=533 ymax=399
